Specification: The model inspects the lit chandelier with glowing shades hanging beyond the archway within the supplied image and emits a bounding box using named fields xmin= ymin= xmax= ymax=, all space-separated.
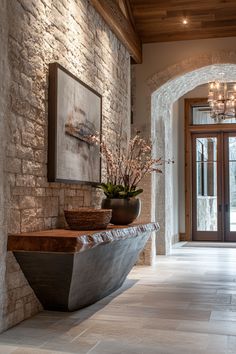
xmin=208 ymin=81 xmax=236 ymax=123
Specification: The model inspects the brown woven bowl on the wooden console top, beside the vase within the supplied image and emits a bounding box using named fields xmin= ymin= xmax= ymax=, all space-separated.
xmin=64 ymin=208 xmax=112 ymax=230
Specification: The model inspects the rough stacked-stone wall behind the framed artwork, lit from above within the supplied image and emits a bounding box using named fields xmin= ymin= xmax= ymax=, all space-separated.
xmin=0 ymin=0 xmax=130 ymax=329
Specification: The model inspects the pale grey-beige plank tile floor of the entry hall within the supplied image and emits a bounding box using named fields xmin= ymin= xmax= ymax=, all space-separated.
xmin=0 ymin=247 xmax=236 ymax=354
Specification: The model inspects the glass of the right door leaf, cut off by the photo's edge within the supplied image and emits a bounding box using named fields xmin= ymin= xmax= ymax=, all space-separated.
xmin=229 ymin=137 xmax=236 ymax=231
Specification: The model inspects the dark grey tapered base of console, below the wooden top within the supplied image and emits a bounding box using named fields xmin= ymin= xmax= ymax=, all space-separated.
xmin=7 ymin=224 xmax=159 ymax=311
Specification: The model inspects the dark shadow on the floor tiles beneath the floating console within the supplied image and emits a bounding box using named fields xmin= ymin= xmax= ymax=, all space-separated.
xmin=0 ymin=279 xmax=138 ymax=354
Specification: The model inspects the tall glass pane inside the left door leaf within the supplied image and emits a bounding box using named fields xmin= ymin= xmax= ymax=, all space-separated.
xmin=196 ymin=137 xmax=217 ymax=231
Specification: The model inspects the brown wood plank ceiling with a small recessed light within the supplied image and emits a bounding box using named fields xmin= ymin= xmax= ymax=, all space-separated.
xmin=129 ymin=0 xmax=236 ymax=43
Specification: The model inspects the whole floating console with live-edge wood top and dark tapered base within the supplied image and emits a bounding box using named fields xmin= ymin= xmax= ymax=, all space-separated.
xmin=8 ymin=223 xmax=159 ymax=311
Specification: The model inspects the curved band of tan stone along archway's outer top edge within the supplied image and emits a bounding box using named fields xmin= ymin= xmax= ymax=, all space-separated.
xmin=147 ymin=50 xmax=236 ymax=93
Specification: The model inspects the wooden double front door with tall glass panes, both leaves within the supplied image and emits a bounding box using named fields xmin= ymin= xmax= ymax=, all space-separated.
xmin=191 ymin=131 xmax=236 ymax=242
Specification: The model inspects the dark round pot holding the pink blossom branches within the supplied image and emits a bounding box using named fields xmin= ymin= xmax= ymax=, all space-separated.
xmin=102 ymin=198 xmax=141 ymax=225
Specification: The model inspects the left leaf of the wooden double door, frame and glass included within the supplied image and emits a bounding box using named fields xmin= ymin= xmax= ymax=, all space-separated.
xmin=193 ymin=134 xmax=220 ymax=241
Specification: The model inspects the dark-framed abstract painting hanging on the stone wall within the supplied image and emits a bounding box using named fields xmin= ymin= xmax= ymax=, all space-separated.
xmin=48 ymin=63 xmax=102 ymax=184
